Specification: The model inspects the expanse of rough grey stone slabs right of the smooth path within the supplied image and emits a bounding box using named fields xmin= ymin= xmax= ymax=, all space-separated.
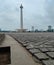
xmin=10 ymin=32 xmax=54 ymax=65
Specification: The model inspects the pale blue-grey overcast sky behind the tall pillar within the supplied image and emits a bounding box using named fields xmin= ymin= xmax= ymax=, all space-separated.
xmin=0 ymin=0 xmax=54 ymax=30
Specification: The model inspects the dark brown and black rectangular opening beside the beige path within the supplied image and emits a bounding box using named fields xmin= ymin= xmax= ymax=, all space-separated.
xmin=0 ymin=46 xmax=11 ymax=65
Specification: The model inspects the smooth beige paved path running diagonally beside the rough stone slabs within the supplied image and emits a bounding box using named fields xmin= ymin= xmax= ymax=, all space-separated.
xmin=1 ymin=35 xmax=40 ymax=65
